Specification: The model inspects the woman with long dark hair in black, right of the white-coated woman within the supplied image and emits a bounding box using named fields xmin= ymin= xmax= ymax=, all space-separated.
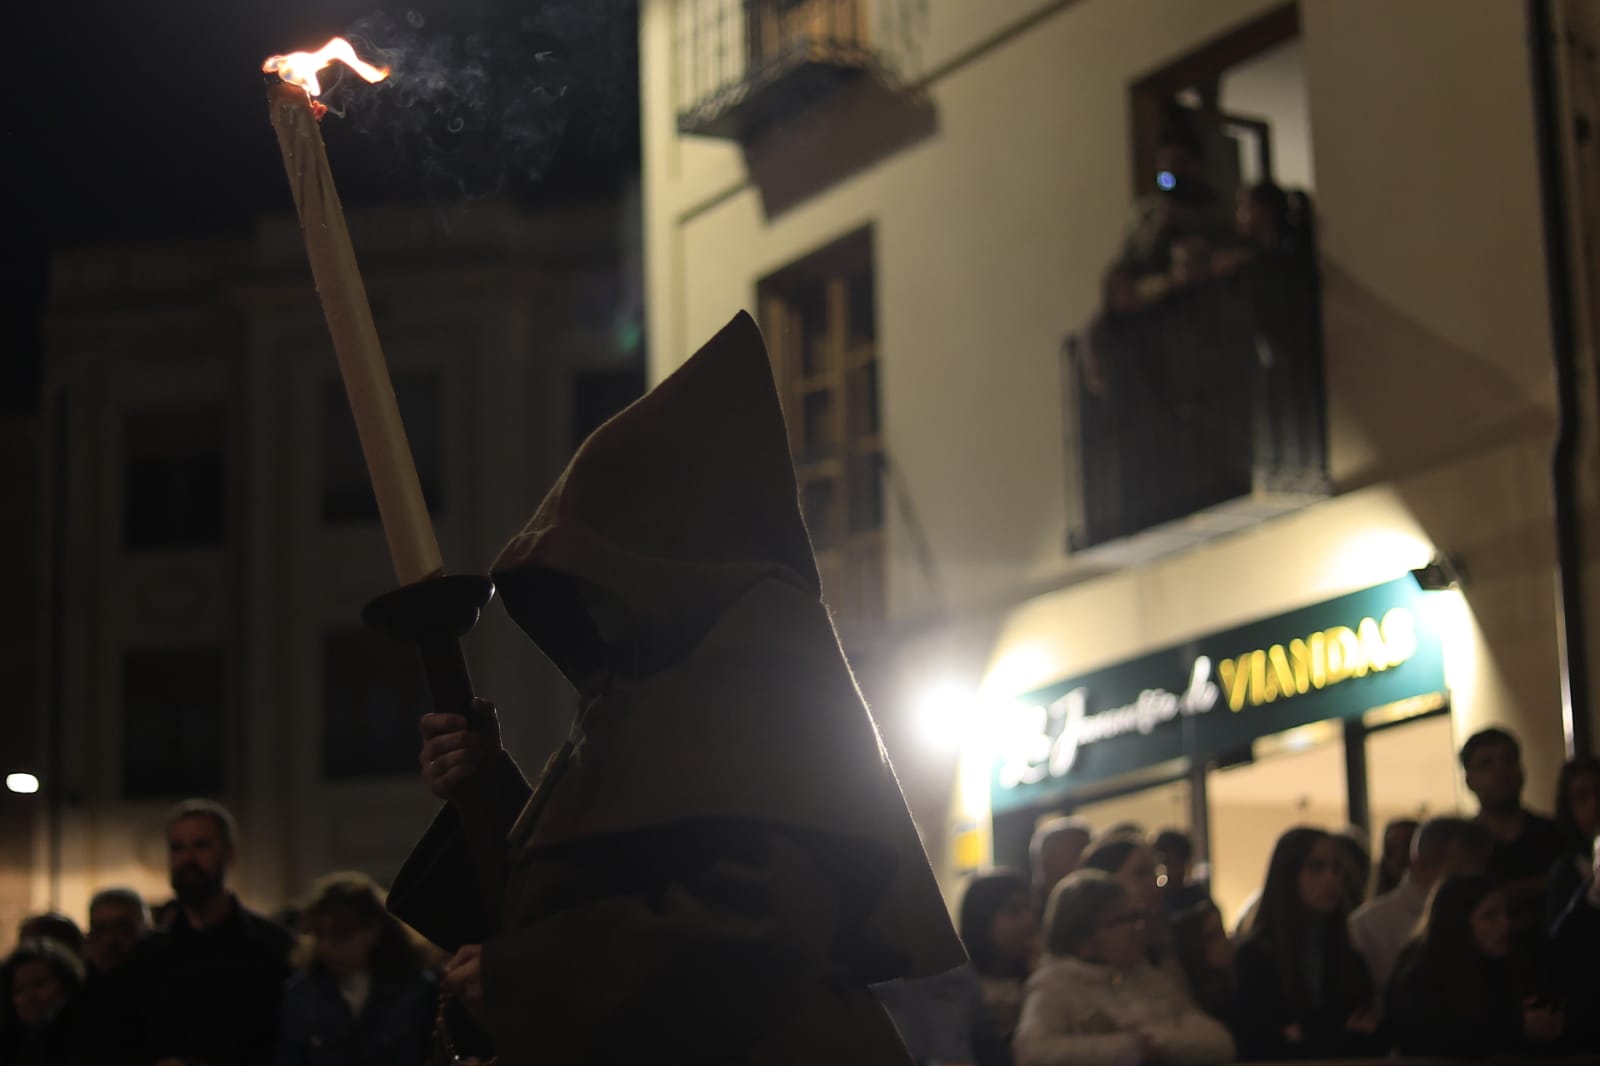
xmin=1234 ymin=826 xmax=1381 ymax=1061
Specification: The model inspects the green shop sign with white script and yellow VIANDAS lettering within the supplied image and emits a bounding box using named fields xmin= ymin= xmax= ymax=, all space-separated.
xmin=990 ymin=576 xmax=1445 ymax=812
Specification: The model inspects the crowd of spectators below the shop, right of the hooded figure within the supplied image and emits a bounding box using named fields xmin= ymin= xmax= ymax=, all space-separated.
xmin=885 ymin=728 xmax=1600 ymax=1066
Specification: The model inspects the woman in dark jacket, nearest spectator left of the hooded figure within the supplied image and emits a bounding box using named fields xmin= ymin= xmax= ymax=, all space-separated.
xmin=277 ymin=872 xmax=438 ymax=1066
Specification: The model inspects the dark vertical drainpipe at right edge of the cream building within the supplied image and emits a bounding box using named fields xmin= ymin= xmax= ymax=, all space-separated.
xmin=1528 ymin=0 xmax=1592 ymax=759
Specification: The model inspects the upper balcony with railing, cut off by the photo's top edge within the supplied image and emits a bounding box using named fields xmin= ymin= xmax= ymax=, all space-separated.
xmin=677 ymin=0 xmax=893 ymax=146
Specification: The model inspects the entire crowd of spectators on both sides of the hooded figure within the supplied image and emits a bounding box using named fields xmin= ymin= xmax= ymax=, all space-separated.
xmin=0 ymin=717 xmax=1600 ymax=1066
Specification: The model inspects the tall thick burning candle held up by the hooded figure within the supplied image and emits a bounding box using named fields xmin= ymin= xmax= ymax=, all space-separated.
xmin=266 ymin=42 xmax=445 ymax=584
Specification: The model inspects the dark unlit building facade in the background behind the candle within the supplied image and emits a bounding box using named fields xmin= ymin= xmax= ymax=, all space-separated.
xmin=30 ymin=203 xmax=643 ymax=916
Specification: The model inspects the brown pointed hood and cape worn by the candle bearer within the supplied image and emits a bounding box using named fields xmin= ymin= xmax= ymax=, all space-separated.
xmin=494 ymin=314 xmax=965 ymax=981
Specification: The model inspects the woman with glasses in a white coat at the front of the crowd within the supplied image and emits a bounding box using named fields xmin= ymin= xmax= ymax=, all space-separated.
xmin=1013 ymin=869 xmax=1234 ymax=1066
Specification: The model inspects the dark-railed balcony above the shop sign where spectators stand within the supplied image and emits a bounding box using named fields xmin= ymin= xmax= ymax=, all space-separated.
xmin=1064 ymin=254 xmax=1330 ymax=563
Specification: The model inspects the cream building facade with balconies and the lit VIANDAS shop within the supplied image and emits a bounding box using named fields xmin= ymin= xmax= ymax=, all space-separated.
xmin=642 ymin=0 xmax=1600 ymax=912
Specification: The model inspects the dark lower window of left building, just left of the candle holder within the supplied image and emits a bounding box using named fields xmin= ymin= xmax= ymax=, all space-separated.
xmin=322 ymin=629 xmax=434 ymax=778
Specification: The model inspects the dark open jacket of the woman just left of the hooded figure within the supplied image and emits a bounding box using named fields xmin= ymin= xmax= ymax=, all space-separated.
xmin=277 ymin=967 xmax=438 ymax=1066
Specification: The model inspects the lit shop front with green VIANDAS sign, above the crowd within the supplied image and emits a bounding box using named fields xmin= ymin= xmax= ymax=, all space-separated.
xmin=989 ymin=575 xmax=1459 ymax=917
